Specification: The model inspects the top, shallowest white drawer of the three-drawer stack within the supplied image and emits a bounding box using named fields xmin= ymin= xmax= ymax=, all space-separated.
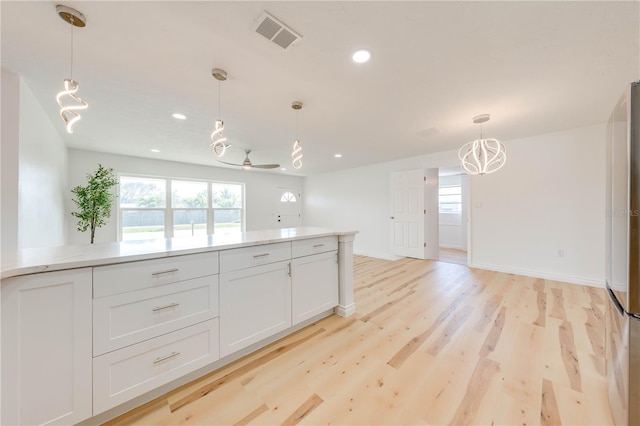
xmin=93 ymin=251 xmax=218 ymax=298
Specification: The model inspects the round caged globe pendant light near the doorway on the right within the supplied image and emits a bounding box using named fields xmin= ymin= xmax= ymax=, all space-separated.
xmin=458 ymin=114 xmax=507 ymax=175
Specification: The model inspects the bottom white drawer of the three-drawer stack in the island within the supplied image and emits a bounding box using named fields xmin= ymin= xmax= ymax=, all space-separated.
xmin=93 ymin=318 xmax=219 ymax=416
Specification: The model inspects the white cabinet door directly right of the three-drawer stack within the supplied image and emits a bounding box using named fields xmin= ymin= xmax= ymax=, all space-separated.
xmin=220 ymin=261 xmax=291 ymax=357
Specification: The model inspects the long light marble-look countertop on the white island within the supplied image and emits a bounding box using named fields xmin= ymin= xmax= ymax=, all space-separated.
xmin=0 ymin=227 xmax=357 ymax=278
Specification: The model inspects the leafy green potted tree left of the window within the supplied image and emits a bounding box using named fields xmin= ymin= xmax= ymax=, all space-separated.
xmin=71 ymin=164 xmax=118 ymax=244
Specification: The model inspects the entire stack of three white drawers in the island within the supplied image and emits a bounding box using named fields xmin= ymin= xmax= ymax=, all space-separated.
xmin=93 ymin=252 xmax=220 ymax=415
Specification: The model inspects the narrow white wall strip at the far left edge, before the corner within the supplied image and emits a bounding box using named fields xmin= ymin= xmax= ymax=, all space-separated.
xmin=0 ymin=68 xmax=20 ymax=254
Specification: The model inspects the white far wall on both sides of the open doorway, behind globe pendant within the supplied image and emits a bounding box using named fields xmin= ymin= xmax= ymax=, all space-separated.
xmin=305 ymin=125 xmax=605 ymax=285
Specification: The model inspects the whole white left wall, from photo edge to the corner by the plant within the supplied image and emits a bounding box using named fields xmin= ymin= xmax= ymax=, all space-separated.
xmin=1 ymin=69 xmax=67 ymax=253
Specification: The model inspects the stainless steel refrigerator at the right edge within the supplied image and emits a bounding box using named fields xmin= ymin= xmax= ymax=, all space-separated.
xmin=606 ymin=81 xmax=640 ymax=425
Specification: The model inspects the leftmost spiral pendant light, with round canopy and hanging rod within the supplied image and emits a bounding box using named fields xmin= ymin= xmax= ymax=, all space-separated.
xmin=56 ymin=5 xmax=89 ymax=133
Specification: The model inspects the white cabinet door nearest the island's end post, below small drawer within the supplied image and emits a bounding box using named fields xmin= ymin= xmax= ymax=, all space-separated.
xmin=291 ymin=251 xmax=338 ymax=325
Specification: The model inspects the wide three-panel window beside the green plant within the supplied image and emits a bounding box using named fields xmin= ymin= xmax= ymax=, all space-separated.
xmin=118 ymin=176 xmax=244 ymax=241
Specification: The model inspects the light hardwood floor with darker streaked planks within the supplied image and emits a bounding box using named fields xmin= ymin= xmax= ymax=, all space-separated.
xmin=110 ymin=256 xmax=612 ymax=425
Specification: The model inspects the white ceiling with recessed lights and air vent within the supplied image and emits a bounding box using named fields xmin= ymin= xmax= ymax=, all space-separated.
xmin=0 ymin=1 xmax=640 ymax=175
